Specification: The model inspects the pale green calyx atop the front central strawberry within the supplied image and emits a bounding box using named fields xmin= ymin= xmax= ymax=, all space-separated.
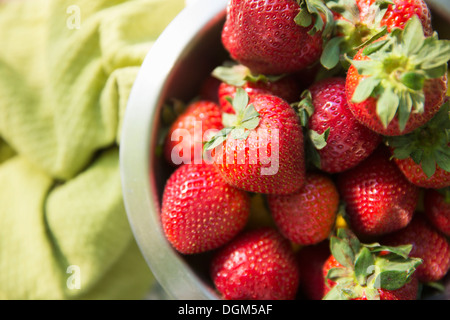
xmin=203 ymin=87 xmax=260 ymax=150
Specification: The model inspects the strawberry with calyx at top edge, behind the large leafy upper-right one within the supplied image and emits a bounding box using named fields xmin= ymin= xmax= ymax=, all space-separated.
xmin=321 ymin=0 xmax=433 ymax=69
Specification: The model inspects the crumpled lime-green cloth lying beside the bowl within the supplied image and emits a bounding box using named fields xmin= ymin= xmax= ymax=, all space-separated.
xmin=0 ymin=0 xmax=184 ymax=300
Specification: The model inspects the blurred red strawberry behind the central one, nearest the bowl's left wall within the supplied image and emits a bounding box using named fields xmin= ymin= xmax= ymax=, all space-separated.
xmin=164 ymin=100 xmax=223 ymax=165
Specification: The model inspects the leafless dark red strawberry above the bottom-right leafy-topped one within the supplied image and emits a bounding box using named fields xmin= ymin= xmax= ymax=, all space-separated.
xmin=337 ymin=145 xmax=419 ymax=236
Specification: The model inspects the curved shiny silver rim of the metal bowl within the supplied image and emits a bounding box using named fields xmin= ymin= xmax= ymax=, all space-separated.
xmin=119 ymin=0 xmax=228 ymax=300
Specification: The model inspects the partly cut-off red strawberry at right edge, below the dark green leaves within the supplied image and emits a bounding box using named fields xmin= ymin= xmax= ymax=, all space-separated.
xmin=423 ymin=188 xmax=450 ymax=237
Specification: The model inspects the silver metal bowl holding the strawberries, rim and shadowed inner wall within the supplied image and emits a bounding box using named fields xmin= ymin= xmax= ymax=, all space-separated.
xmin=120 ymin=0 xmax=450 ymax=300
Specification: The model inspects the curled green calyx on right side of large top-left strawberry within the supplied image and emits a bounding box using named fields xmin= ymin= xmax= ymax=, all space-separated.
xmin=294 ymin=0 xmax=334 ymax=39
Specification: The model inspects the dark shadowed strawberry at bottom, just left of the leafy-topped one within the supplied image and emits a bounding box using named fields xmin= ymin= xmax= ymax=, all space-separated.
xmin=296 ymin=240 xmax=330 ymax=300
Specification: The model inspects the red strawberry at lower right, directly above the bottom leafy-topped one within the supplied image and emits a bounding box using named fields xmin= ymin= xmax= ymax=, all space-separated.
xmin=383 ymin=212 xmax=450 ymax=283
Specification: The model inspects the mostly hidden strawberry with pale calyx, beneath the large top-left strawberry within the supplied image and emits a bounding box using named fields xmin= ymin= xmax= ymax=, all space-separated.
xmin=212 ymin=64 xmax=301 ymax=113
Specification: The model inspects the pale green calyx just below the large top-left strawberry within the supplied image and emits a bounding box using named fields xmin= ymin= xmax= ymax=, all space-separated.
xmin=211 ymin=62 xmax=285 ymax=87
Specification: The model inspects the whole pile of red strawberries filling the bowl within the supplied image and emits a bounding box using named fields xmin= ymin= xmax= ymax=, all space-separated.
xmin=156 ymin=0 xmax=450 ymax=300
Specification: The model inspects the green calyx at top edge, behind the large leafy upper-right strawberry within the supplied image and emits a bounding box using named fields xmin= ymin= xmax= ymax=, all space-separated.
xmin=320 ymin=0 xmax=393 ymax=70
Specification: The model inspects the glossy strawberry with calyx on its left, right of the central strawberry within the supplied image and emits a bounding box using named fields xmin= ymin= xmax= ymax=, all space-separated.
xmin=298 ymin=77 xmax=381 ymax=173
